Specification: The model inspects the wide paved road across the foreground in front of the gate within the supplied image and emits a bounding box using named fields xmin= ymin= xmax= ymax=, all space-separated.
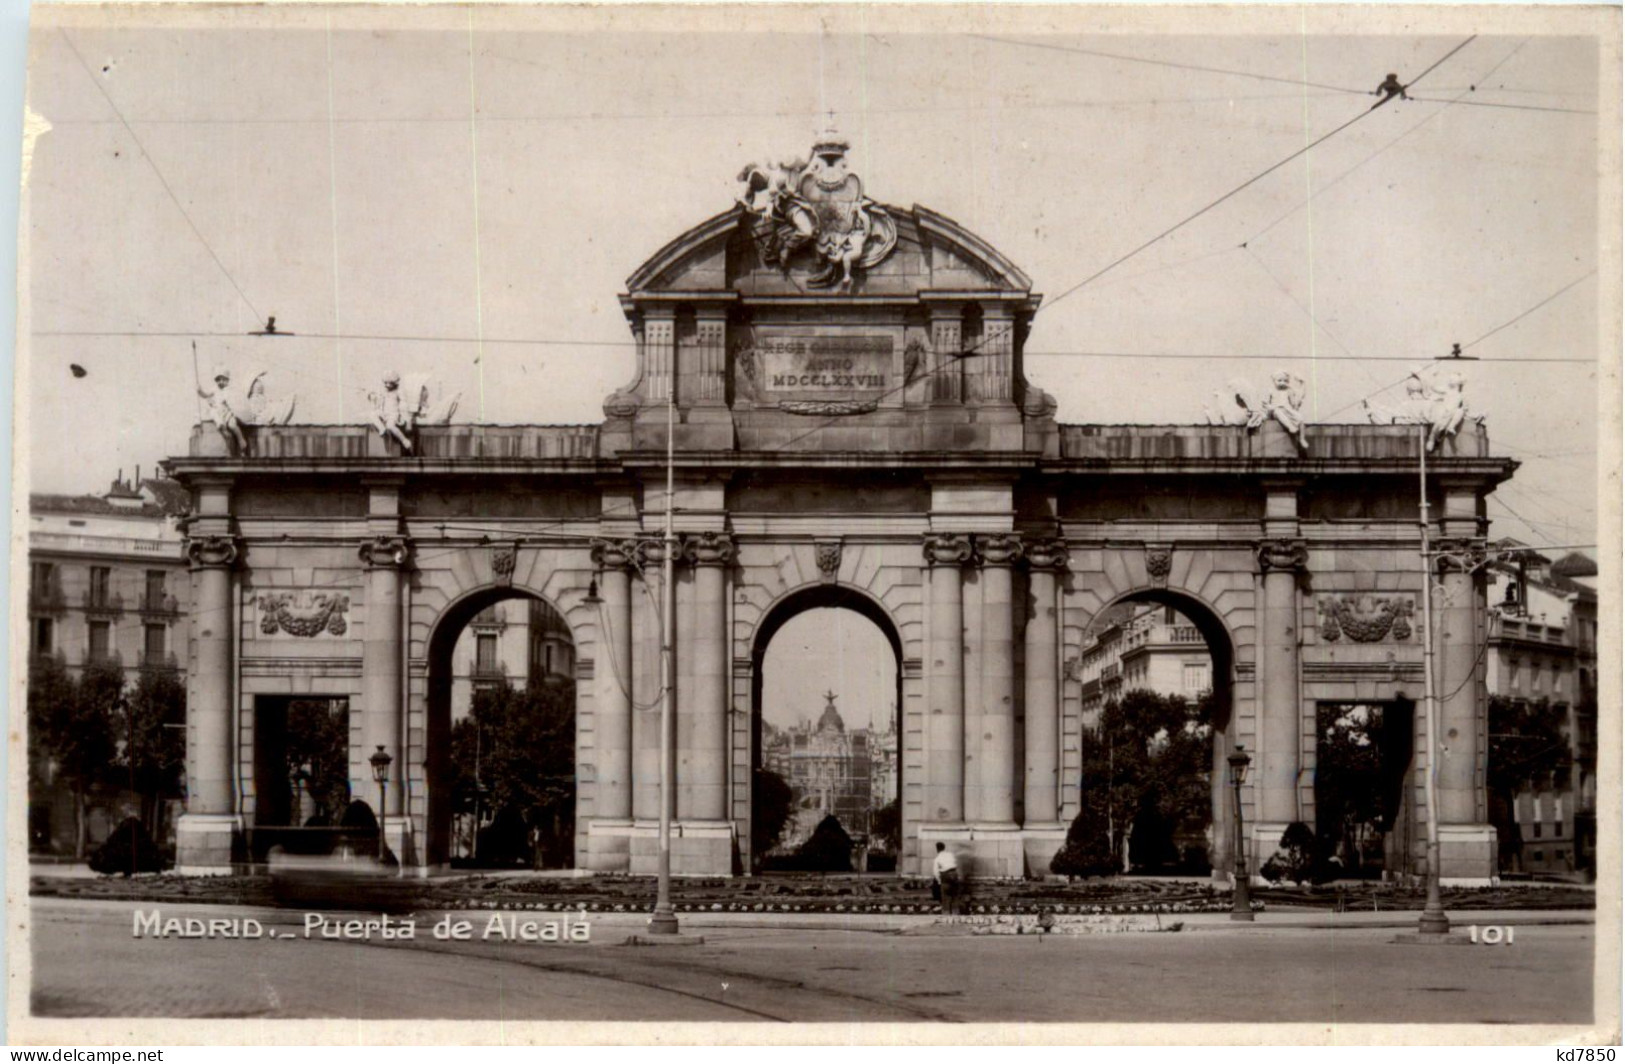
xmin=33 ymin=898 xmax=1594 ymax=1023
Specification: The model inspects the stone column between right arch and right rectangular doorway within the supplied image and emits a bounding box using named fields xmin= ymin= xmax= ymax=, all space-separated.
xmin=1253 ymin=538 xmax=1308 ymax=828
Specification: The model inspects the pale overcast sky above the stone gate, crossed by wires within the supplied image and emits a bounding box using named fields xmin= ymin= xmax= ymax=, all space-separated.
xmin=18 ymin=5 xmax=1619 ymax=558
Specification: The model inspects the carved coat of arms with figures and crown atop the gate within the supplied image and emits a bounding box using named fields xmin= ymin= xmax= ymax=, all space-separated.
xmin=739 ymin=136 xmax=897 ymax=289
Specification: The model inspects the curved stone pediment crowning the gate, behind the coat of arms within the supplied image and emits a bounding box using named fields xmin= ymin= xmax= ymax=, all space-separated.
xmin=627 ymin=203 xmax=1032 ymax=302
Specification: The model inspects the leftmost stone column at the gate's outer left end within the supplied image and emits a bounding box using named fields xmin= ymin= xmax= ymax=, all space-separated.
xmin=176 ymin=534 xmax=241 ymax=874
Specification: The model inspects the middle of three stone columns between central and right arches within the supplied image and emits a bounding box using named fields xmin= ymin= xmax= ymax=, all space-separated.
xmin=965 ymin=534 xmax=1022 ymax=828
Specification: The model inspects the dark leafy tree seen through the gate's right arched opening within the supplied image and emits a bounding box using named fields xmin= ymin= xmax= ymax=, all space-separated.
xmin=1069 ymin=689 xmax=1214 ymax=874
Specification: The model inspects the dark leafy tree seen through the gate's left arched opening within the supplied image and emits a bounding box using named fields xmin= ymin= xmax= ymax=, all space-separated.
xmin=452 ymin=677 xmax=575 ymax=867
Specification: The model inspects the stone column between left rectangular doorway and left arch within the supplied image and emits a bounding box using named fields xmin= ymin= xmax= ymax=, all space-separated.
xmin=359 ymin=536 xmax=411 ymax=818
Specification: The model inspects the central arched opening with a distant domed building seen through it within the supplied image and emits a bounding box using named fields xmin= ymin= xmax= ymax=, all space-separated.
xmin=748 ymin=583 xmax=905 ymax=874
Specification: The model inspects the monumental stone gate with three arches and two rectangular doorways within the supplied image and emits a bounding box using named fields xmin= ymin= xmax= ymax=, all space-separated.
xmin=171 ymin=141 xmax=1515 ymax=880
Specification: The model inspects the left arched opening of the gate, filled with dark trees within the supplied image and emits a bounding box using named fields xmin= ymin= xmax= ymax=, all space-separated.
xmin=424 ymin=586 xmax=579 ymax=867
